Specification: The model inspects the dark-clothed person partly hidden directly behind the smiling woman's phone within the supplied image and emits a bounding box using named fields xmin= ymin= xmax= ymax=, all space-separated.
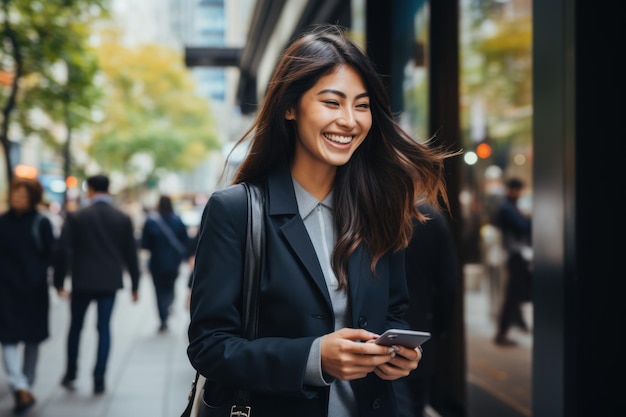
xmin=396 ymin=204 xmax=461 ymax=417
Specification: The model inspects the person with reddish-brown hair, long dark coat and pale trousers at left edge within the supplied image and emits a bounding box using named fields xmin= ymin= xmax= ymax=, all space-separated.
xmin=0 ymin=177 xmax=54 ymax=413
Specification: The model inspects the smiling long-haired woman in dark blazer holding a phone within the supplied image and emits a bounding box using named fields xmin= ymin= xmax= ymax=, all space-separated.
xmin=188 ymin=26 xmax=449 ymax=417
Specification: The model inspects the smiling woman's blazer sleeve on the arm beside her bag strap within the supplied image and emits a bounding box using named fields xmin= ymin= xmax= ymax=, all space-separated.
xmin=187 ymin=185 xmax=317 ymax=398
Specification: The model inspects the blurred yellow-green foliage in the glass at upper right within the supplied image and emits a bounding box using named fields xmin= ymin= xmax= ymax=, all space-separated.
xmin=461 ymin=6 xmax=532 ymax=148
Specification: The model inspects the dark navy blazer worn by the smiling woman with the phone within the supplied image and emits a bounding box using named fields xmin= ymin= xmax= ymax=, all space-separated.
xmin=188 ymin=165 xmax=408 ymax=417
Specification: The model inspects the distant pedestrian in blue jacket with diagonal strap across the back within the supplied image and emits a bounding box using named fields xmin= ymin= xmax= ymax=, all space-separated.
xmin=141 ymin=195 xmax=189 ymax=332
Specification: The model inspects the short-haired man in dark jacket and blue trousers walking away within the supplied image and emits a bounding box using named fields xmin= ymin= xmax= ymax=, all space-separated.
xmin=54 ymin=175 xmax=139 ymax=394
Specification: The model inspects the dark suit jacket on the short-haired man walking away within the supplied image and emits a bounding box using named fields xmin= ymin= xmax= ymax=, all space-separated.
xmin=54 ymin=201 xmax=139 ymax=293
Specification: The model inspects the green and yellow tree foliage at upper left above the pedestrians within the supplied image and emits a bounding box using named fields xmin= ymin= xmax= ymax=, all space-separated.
xmin=0 ymin=0 xmax=220 ymax=197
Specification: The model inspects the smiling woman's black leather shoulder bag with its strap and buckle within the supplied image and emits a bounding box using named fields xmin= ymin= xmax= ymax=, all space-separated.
xmin=181 ymin=183 xmax=265 ymax=417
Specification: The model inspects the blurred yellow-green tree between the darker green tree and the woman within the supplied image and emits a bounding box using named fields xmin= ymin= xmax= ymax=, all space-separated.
xmin=88 ymin=30 xmax=220 ymax=186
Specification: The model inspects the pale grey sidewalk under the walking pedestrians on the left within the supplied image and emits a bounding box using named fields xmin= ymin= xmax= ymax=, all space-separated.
xmin=0 ymin=265 xmax=195 ymax=417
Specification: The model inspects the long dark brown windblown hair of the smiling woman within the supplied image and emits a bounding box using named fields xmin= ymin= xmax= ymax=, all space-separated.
xmin=233 ymin=25 xmax=453 ymax=288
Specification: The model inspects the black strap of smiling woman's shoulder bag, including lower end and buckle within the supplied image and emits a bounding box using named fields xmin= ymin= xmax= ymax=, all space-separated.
xmin=181 ymin=182 xmax=265 ymax=417
